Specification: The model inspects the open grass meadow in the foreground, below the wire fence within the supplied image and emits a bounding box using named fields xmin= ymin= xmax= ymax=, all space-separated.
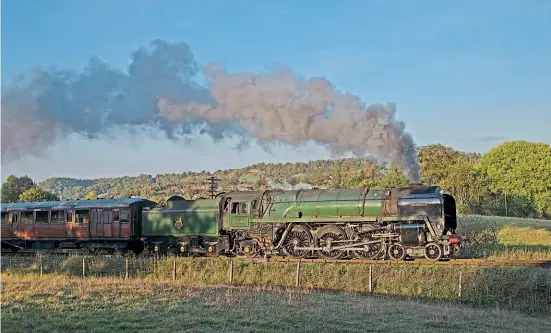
xmin=2 ymin=274 xmax=551 ymax=333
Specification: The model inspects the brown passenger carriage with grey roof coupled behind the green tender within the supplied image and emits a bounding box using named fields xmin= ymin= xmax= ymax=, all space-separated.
xmin=1 ymin=198 xmax=155 ymax=253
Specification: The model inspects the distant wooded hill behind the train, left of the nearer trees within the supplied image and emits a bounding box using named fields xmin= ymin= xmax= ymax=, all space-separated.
xmin=39 ymin=158 xmax=409 ymax=201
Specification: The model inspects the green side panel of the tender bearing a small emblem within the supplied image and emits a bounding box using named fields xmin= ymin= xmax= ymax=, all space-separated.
xmin=142 ymin=199 xmax=219 ymax=237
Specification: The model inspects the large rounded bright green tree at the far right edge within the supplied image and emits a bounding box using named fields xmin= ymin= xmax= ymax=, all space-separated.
xmin=478 ymin=141 xmax=551 ymax=215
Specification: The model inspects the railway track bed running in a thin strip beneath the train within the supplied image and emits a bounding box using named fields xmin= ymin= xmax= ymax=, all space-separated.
xmin=2 ymin=251 xmax=551 ymax=268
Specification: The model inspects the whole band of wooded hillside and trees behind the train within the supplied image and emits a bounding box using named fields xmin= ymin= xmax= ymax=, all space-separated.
xmin=2 ymin=141 xmax=551 ymax=218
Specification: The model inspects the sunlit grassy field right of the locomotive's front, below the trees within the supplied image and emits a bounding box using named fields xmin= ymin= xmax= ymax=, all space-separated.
xmin=458 ymin=215 xmax=551 ymax=260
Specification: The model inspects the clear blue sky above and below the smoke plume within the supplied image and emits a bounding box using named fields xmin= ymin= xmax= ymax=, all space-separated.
xmin=1 ymin=0 xmax=551 ymax=181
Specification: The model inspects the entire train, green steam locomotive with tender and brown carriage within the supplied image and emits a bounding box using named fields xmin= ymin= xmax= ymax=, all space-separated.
xmin=1 ymin=185 xmax=467 ymax=260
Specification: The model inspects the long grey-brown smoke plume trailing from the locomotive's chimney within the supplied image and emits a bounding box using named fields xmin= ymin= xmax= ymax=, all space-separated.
xmin=2 ymin=40 xmax=419 ymax=181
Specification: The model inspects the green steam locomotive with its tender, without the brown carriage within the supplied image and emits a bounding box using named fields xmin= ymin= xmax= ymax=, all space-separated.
xmin=141 ymin=184 xmax=467 ymax=261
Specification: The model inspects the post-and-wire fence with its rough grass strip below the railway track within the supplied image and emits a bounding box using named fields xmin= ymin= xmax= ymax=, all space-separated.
xmin=1 ymin=254 xmax=551 ymax=314
